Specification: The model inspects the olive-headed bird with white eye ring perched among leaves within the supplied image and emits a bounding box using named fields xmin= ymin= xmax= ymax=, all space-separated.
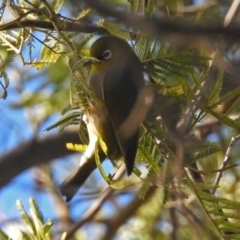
xmin=60 ymin=36 xmax=152 ymax=200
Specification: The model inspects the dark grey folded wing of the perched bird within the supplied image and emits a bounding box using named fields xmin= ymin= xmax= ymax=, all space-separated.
xmin=103 ymin=68 xmax=139 ymax=175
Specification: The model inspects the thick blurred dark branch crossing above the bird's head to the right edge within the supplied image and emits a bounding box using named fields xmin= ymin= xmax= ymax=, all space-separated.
xmin=84 ymin=0 xmax=240 ymax=38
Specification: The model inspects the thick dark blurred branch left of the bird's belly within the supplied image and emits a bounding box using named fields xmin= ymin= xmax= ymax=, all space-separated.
xmin=0 ymin=128 xmax=79 ymax=188
